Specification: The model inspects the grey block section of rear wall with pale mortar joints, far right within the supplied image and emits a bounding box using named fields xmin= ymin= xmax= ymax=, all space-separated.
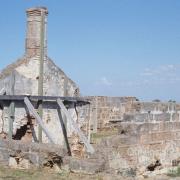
xmin=123 ymin=102 xmax=180 ymax=123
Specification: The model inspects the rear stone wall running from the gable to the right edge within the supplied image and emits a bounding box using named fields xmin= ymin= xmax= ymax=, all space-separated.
xmin=79 ymin=96 xmax=180 ymax=129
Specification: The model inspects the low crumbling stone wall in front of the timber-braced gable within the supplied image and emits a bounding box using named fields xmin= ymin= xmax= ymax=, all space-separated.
xmin=0 ymin=139 xmax=105 ymax=174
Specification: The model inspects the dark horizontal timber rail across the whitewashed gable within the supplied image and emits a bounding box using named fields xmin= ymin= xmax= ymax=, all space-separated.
xmin=0 ymin=95 xmax=90 ymax=106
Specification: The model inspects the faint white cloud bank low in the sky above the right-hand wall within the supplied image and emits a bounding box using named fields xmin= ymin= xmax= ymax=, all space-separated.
xmin=96 ymin=64 xmax=180 ymax=88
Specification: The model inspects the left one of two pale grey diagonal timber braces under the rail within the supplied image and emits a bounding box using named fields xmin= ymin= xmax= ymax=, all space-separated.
xmin=24 ymin=97 xmax=54 ymax=143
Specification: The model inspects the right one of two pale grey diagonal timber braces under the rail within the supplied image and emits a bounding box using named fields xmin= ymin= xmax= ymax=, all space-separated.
xmin=57 ymin=98 xmax=94 ymax=153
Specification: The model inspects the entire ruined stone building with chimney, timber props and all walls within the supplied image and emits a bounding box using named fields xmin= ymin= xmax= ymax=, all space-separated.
xmin=0 ymin=7 xmax=180 ymax=179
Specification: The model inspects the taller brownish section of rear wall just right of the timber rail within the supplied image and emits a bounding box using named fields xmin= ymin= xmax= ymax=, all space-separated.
xmin=80 ymin=96 xmax=136 ymax=129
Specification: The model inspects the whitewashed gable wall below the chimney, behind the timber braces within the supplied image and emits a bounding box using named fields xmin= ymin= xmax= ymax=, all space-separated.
xmin=0 ymin=57 xmax=79 ymax=144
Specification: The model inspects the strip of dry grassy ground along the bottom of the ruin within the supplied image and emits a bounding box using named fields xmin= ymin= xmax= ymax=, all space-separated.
xmin=0 ymin=166 xmax=180 ymax=180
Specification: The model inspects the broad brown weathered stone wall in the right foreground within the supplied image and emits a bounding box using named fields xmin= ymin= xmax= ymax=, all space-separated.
xmin=94 ymin=122 xmax=180 ymax=173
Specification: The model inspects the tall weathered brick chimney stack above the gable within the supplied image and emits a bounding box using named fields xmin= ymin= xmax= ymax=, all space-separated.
xmin=26 ymin=7 xmax=48 ymax=58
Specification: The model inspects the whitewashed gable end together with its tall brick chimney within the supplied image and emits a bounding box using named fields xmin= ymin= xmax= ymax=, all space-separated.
xmin=0 ymin=7 xmax=79 ymax=144
